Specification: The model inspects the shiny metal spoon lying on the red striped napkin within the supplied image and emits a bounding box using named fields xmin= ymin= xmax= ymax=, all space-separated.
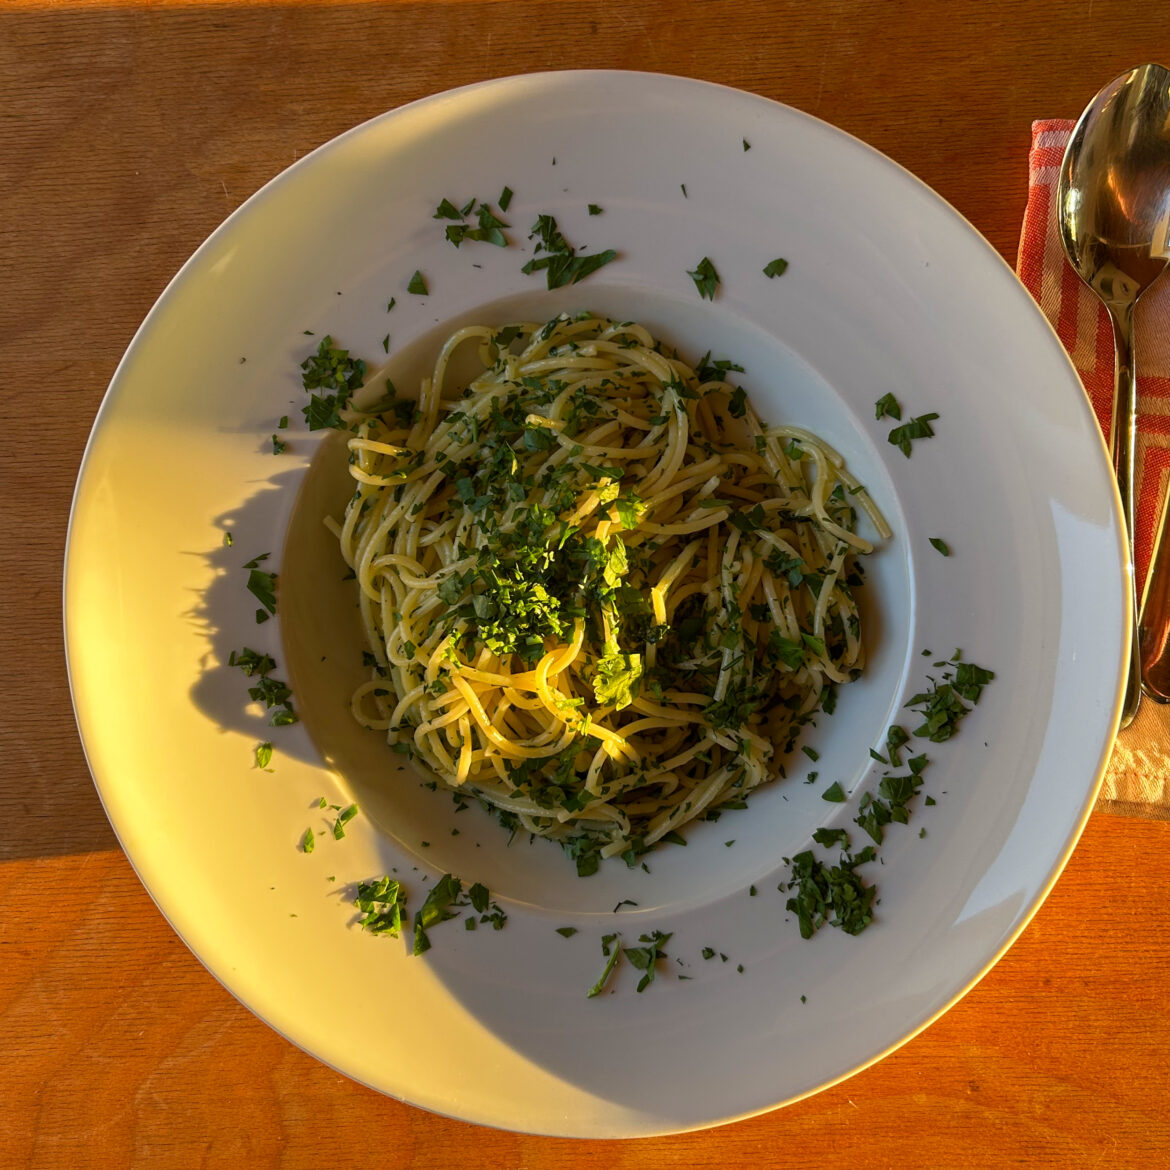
xmin=1057 ymin=64 xmax=1170 ymax=727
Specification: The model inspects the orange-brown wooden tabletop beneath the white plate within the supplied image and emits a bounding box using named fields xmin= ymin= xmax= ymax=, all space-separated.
xmin=0 ymin=0 xmax=1170 ymax=1170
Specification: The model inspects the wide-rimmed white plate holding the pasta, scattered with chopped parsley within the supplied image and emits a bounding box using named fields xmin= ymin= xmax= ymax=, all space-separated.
xmin=66 ymin=73 xmax=1128 ymax=1137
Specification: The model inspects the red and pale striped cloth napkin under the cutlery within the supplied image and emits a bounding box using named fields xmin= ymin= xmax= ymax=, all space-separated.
xmin=1016 ymin=119 xmax=1170 ymax=820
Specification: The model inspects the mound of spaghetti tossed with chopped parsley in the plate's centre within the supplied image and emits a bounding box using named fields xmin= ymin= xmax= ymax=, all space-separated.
xmin=329 ymin=314 xmax=889 ymax=873
